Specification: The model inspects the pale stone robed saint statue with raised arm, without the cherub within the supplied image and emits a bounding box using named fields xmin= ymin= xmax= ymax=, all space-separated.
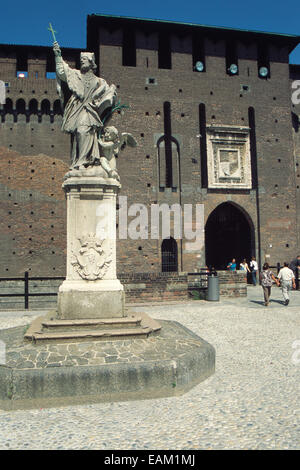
xmin=53 ymin=41 xmax=117 ymax=170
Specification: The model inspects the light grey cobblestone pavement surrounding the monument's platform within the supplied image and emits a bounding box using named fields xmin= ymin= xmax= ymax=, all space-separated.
xmin=0 ymin=287 xmax=300 ymax=449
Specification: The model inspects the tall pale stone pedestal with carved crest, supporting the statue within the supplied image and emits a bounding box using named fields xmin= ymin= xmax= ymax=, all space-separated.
xmin=58 ymin=172 xmax=125 ymax=319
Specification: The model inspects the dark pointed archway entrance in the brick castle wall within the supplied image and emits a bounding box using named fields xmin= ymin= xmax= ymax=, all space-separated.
xmin=205 ymin=202 xmax=255 ymax=269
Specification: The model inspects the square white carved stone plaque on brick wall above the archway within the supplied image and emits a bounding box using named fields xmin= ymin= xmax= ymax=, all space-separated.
xmin=207 ymin=126 xmax=252 ymax=189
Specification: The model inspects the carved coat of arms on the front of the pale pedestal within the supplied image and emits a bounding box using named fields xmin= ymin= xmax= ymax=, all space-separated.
xmin=71 ymin=234 xmax=112 ymax=281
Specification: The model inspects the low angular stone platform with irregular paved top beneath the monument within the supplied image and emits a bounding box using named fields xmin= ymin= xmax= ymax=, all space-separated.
xmin=0 ymin=314 xmax=215 ymax=410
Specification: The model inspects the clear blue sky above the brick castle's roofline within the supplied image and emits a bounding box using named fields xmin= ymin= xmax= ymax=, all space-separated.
xmin=0 ymin=0 xmax=300 ymax=64
